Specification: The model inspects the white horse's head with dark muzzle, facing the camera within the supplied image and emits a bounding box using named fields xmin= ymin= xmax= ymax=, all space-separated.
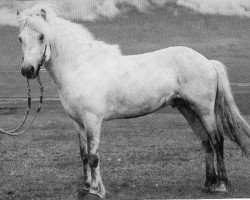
xmin=18 ymin=8 xmax=51 ymax=79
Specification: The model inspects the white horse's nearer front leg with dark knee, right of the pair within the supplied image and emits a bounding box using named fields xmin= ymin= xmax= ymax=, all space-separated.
xmin=86 ymin=114 xmax=106 ymax=198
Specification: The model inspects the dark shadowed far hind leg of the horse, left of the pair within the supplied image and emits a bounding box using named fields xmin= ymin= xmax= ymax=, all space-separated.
xmin=175 ymin=99 xmax=217 ymax=190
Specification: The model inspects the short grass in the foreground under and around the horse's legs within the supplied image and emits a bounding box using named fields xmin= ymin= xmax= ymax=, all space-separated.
xmin=0 ymin=101 xmax=250 ymax=200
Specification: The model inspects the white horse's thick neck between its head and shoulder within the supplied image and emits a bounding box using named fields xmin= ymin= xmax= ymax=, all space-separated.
xmin=46 ymin=19 xmax=94 ymax=89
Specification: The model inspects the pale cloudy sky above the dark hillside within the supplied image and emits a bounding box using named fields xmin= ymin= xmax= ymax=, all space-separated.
xmin=0 ymin=0 xmax=250 ymax=26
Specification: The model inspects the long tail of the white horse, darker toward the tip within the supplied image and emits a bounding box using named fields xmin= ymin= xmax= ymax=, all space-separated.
xmin=212 ymin=60 xmax=250 ymax=155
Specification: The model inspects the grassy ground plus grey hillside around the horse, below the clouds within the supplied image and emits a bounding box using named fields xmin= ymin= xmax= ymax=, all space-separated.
xmin=0 ymin=6 xmax=250 ymax=200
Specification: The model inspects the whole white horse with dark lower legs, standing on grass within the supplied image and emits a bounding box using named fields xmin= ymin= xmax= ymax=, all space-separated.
xmin=19 ymin=4 xmax=250 ymax=197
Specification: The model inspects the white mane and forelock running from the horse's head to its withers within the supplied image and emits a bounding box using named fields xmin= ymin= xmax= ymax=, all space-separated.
xmin=20 ymin=2 xmax=121 ymax=55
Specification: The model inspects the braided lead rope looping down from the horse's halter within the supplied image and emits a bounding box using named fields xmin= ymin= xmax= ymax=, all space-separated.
xmin=0 ymin=74 xmax=44 ymax=136
